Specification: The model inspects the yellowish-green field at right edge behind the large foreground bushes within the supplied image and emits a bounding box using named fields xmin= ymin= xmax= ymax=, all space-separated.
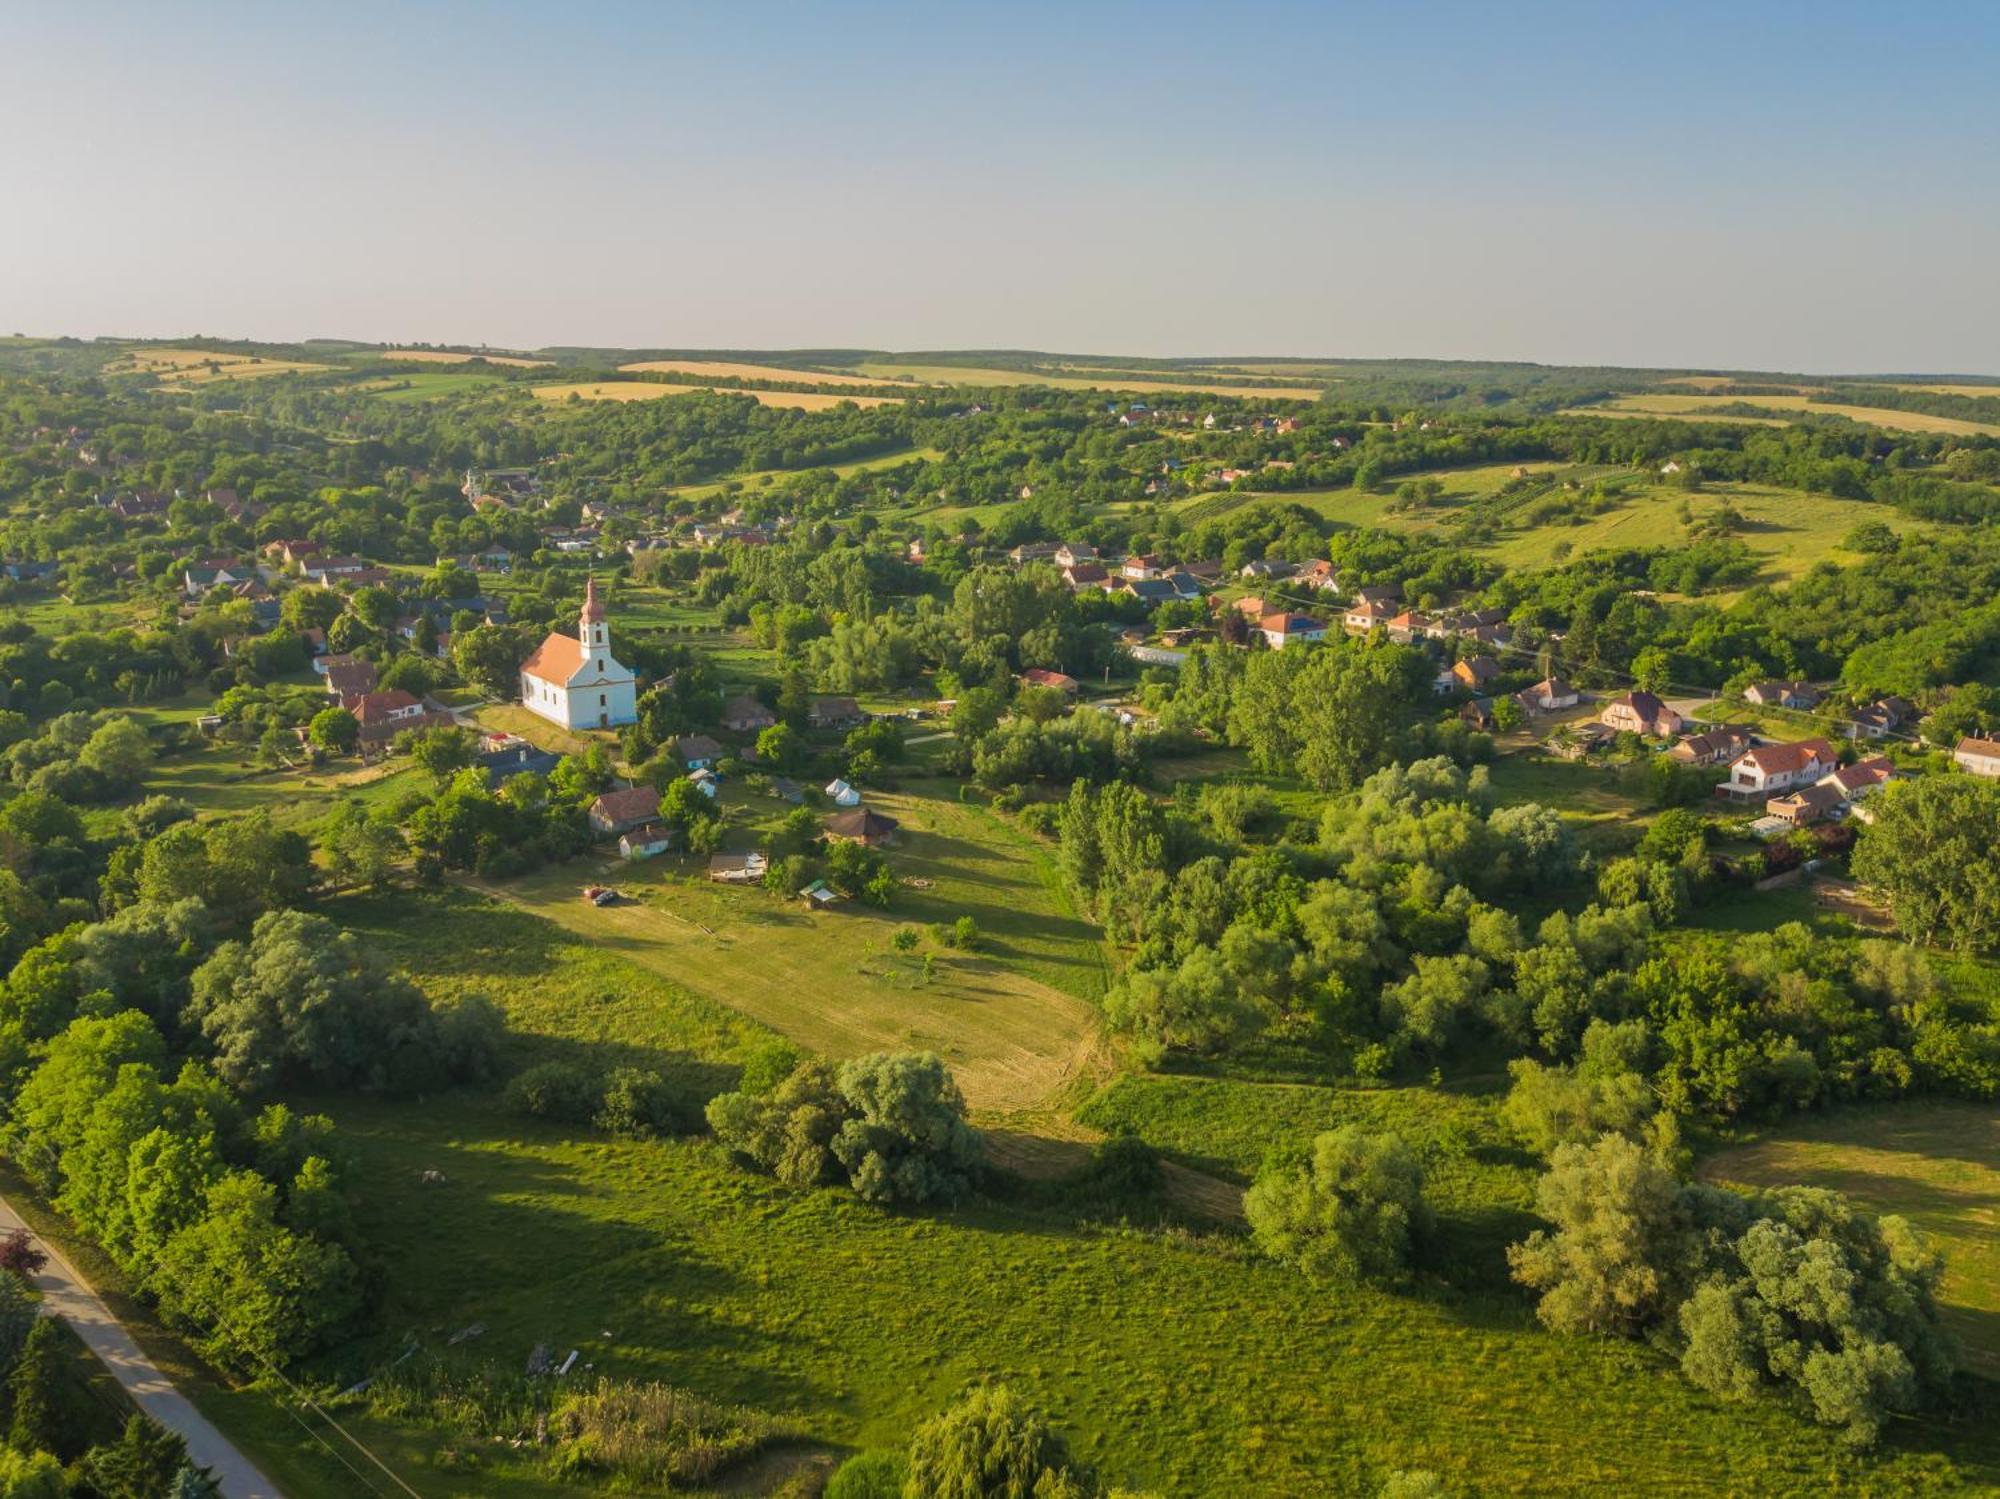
xmin=1702 ymin=1103 xmax=2000 ymax=1375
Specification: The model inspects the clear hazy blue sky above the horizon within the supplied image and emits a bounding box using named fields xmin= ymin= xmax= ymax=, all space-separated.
xmin=0 ymin=0 xmax=2000 ymax=374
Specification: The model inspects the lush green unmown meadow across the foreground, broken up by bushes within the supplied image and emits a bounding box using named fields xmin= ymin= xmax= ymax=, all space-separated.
xmin=300 ymin=895 xmax=2000 ymax=1495
